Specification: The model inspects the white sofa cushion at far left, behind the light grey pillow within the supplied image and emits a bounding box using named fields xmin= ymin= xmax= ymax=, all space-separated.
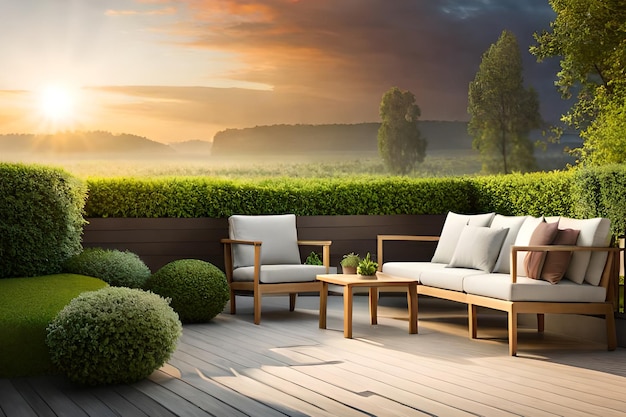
xmin=431 ymin=212 xmax=495 ymax=264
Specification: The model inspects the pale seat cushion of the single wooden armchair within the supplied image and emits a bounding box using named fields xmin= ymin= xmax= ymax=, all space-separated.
xmin=233 ymin=265 xmax=326 ymax=284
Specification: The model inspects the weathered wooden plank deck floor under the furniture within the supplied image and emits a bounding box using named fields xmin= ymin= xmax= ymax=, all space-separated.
xmin=0 ymin=296 xmax=626 ymax=417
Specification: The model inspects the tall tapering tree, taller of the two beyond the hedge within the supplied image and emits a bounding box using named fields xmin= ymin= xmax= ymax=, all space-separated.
xmin=467 ymin=30 xmax=542 ymax=174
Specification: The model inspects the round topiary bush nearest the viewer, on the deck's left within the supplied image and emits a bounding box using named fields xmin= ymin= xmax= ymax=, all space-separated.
xmin=46 ymin=287 xmax=182 ymax=385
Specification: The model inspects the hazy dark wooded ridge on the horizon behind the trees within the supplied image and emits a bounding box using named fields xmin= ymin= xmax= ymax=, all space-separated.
xmin=212 ymin=121 xmax=472 ymax=156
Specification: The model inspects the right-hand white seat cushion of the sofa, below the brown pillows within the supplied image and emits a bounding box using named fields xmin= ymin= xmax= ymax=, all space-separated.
xmin=463 ymin=274 xmax=606 ymax=302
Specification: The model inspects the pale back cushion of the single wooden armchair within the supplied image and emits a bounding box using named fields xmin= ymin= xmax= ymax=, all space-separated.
xmin=228 ymin=214 xmax=302 ymax=268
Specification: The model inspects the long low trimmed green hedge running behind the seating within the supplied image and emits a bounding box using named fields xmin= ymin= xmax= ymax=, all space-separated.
xmin=86 ymin=165 xmax=626 ymax=234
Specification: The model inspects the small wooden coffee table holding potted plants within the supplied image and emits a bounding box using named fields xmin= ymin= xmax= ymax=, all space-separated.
xmin=317 ymin=273 xmax=417 ymax=338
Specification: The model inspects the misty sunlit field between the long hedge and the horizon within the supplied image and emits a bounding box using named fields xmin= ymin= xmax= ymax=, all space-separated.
xmin=1 ymin=143 xmax=573 ymax=178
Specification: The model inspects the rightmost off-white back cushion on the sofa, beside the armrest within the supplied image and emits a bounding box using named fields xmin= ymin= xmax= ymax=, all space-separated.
xmin=559 ymin=217 xmax=611 ymax=285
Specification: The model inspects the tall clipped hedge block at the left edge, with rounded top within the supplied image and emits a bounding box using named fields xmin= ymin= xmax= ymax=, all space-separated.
xmin=0 ymin=163 xmax=86 ymax=278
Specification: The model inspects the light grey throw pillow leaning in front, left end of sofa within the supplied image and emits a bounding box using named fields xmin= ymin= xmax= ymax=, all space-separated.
xmin=447 ymin=225 xmax=509 ymax=272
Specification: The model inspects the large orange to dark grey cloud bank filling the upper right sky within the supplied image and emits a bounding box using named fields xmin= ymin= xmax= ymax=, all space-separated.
xmin=154 ymin=0 xmax=554 ymax=119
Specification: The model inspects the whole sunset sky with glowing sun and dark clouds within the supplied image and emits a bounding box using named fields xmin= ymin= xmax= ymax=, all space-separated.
xmin=0 ymin=0 xmax=565 ymax=142
